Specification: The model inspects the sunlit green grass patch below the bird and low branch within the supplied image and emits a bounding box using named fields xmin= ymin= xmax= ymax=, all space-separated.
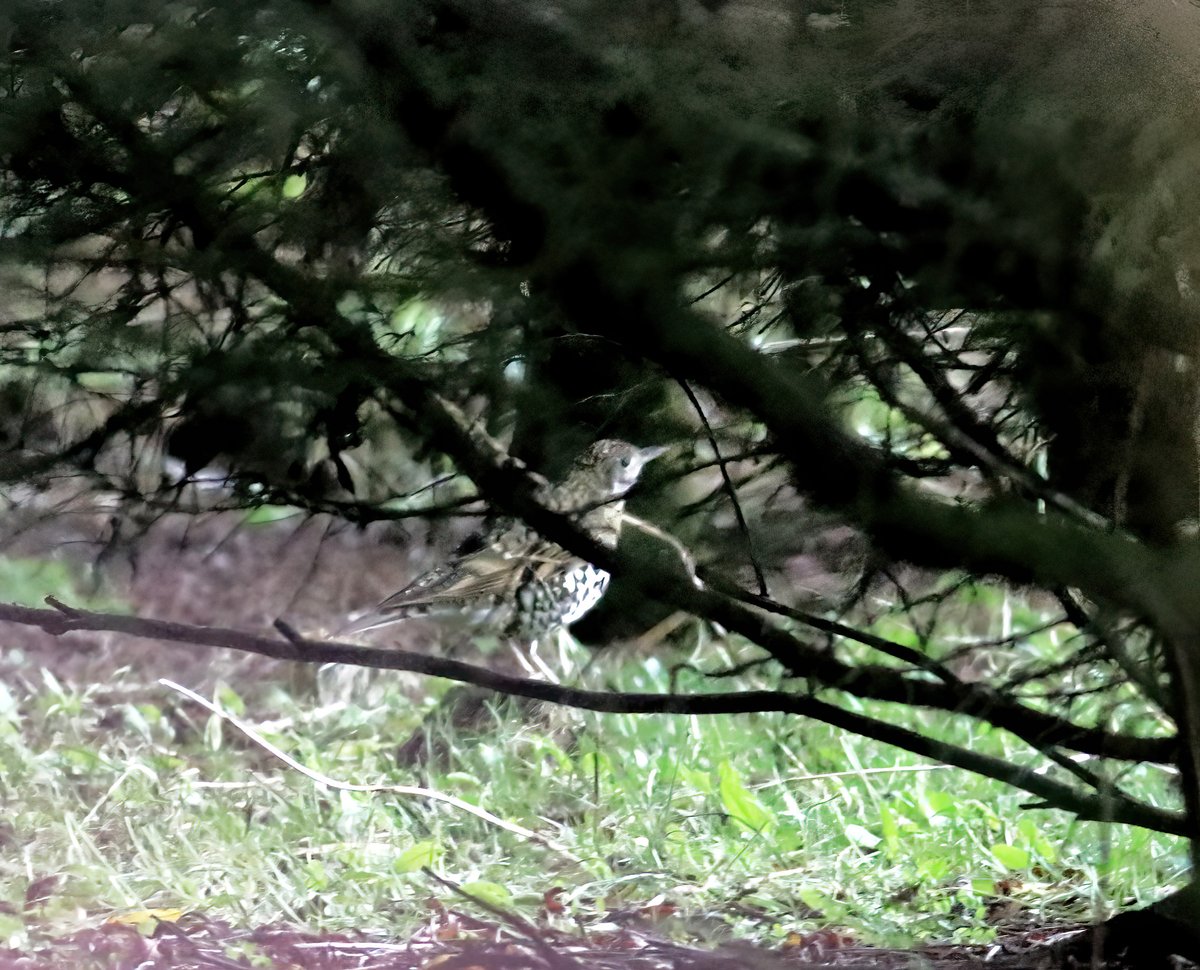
xmin=0 ymin=619 xmax=1186 ymax=945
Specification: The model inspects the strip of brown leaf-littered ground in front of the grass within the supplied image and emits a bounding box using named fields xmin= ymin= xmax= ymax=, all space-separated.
xmin=0 ymin=908 xmax=1113 ymax=970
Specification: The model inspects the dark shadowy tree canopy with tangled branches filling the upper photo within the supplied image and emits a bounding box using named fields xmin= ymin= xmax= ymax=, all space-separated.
xmin=7 ymin=0 xmax=1200 ymax=936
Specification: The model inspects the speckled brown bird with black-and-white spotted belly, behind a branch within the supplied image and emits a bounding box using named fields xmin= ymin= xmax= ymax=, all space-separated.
xmin=341 ymin=438 xmax=667 ymax=643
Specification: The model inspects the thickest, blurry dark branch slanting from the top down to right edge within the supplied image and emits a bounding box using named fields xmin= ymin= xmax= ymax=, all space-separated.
xmin=302 ymin=2 xmax=1200 ymax=629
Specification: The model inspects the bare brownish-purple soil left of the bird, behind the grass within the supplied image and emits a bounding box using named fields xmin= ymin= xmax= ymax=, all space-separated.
xmin=0 ymin=510 xmax=464 ymax=693
